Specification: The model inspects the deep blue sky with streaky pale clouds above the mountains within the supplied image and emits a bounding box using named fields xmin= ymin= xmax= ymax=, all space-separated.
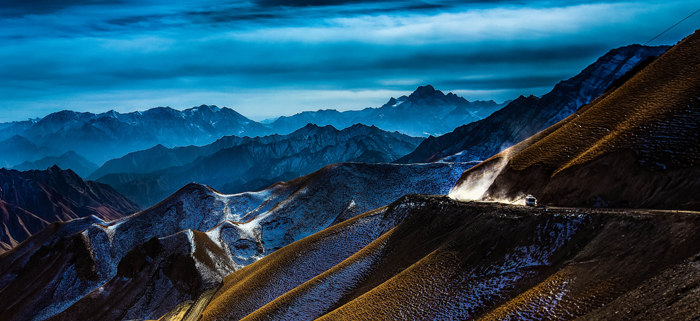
xmin=0 ymin=0 xmax=700 ymax=122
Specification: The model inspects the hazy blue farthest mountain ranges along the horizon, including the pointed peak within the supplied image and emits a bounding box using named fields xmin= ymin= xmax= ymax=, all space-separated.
xmin=0 ymin=86 xmax=502 ymax=168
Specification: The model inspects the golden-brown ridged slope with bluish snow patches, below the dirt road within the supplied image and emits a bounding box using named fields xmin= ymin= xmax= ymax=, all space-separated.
xmin=191 ymin=195 xmax=700 ymax=320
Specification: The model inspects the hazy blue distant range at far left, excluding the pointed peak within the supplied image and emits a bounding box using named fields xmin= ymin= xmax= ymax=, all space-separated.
xmin=0 ymin=105 xmax=269 ymax=166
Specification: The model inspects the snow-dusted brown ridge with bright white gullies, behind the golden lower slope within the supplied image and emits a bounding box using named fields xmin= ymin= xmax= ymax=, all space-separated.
xmin=0 ymin=163 xmax=469 ymax=320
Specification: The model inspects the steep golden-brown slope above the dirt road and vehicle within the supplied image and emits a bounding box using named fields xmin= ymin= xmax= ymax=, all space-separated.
xmin=457 ymin=32 xmax=700 ymax=208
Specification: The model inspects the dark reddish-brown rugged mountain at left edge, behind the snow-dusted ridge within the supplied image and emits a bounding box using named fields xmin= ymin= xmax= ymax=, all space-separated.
xmin=0 ymin=166 xmax=140 ymax=253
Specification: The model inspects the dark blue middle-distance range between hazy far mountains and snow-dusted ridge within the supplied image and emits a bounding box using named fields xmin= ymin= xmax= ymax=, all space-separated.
xmin=90 ymin=124 xmax=423 ymax=207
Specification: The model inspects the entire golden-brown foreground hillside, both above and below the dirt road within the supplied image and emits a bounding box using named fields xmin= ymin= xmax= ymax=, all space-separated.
xmin=150 ymin=32 xmax=700 ymax=320
